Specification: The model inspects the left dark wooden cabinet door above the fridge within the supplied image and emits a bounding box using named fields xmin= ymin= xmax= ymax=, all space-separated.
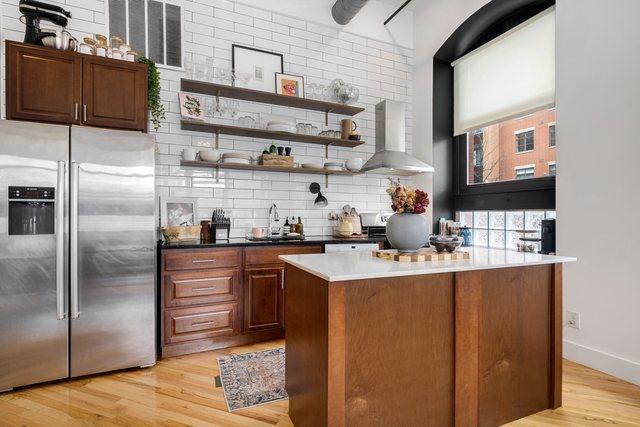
xmin=6 ymin=42 xmax=82 ymax=124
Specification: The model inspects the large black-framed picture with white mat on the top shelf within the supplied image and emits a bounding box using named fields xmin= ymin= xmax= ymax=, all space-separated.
xmin=231 ymin=44 xmax=284 ymax=93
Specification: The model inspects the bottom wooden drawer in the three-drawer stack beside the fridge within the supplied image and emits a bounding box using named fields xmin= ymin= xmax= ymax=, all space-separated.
xmin=164 ymin=303 xmax=240 ymax=344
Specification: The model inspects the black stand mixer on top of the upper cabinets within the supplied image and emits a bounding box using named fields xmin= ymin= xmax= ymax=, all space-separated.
xmin=19 ymin=0 xmax=71 ymax=45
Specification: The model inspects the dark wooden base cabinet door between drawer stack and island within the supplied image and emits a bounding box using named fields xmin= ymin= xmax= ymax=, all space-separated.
xmin=244 ymin=267 xmax=284 ymax=332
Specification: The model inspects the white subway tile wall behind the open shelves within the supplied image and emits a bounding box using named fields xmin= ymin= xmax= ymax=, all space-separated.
xmin=0 ymin=0 xmax=413 ymax=237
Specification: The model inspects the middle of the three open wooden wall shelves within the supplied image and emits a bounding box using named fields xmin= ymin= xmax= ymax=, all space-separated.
xmin=180 ymin=120 xmax=364 ymax=148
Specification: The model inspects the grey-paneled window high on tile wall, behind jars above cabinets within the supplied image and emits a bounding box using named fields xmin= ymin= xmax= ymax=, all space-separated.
xmin=108 ymin=0 xmax=182 ymax=67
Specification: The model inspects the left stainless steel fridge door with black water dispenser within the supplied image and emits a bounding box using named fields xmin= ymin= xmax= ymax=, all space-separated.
xmin=0 ymin=120 xmax=69 ymax=390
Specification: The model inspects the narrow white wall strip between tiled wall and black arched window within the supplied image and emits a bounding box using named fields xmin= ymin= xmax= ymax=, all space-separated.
xmin=412 ymin=0 xmax=489 ymax=226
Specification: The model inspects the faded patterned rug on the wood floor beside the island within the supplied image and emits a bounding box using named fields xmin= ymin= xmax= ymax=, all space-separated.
xmin=218 ymin=348 xmax=288 ymax=411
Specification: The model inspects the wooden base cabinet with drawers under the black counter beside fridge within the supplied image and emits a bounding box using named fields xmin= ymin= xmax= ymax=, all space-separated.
xmin=159 ymin=245 xmax=323 ymax=356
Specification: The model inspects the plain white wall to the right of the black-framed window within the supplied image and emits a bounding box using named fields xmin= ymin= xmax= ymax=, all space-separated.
xmin=556 ymin=0 xmax=640 ymax=384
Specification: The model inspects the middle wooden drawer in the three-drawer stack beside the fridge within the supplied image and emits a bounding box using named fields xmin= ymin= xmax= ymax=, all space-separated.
xmin=164 ymin=269 xmax=240 ymax=307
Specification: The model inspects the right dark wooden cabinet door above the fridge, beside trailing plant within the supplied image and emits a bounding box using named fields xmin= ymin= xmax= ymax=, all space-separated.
xmin=82 ymin=57 xmax=147 ymax=131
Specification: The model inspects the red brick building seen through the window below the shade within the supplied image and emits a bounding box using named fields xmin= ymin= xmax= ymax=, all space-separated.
xmin=467 ymin=108 xmax=556 ymax=184
